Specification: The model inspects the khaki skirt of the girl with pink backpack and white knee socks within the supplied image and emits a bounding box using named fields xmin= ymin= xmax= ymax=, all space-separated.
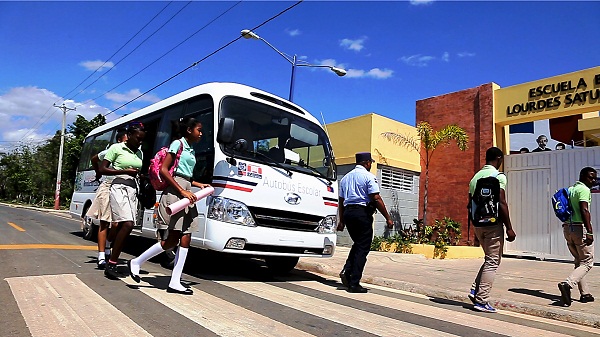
xmin=158 ymin=176 xmax=199 ymax=235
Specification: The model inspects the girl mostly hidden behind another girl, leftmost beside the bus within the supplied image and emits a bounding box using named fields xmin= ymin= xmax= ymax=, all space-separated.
xmin=87 ymin=130 xmax=127 ymax=269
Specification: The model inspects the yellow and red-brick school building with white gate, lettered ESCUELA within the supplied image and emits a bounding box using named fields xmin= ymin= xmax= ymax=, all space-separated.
xmin=327 ymin=66 xmax=600 ymax=258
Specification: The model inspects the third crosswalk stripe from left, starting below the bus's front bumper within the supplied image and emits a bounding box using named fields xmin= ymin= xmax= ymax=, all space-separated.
xmin=215 ymin=281 xmax=456 ymax=336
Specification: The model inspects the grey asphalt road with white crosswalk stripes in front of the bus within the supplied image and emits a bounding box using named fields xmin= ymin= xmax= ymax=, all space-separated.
xmin=0 ymin=205 xmax=599 ymax=337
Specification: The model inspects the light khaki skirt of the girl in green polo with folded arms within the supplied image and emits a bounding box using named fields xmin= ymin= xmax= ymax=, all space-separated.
xmin=110 ymin=175 xmax=138 ymax=226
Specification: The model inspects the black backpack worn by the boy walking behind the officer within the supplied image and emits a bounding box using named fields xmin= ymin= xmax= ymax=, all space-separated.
xmin=471 ymin=173 xmax=500 ymax=227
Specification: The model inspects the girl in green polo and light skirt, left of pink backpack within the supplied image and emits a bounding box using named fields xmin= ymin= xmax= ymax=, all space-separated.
xmin=100 ymin=122 xmax=146 ymax=279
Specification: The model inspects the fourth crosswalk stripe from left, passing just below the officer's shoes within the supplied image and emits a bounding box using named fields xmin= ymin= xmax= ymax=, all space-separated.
xmin=287 ymin=281 xmax=597 ymax=337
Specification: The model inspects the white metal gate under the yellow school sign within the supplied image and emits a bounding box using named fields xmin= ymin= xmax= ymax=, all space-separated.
xmin=504 ymin=147 xmax=600 ymax=260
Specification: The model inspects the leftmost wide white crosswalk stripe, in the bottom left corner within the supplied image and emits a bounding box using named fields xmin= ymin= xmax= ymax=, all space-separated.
xmin=6 ymin=274 xmax=151 ymax=337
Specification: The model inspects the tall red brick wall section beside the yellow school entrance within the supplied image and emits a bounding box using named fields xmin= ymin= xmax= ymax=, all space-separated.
xmin=416 ymin=83 xmax=494 ymax=245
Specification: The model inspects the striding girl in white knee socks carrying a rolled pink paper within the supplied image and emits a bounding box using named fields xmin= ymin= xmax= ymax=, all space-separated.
xmin=127 ymin=117 xmax=210 ymax=295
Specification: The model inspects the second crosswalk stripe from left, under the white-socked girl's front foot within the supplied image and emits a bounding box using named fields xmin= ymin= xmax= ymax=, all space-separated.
xmin=122 ymin=273 xmax=312 ymax=337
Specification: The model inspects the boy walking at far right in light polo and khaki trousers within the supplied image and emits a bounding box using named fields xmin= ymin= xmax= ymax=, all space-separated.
xmin=558 ymin=167 xmax=598 ymax=307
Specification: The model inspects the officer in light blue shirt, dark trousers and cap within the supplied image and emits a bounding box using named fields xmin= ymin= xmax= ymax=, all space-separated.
xmin=337 ymin=152 xmax=394 ymax=293
